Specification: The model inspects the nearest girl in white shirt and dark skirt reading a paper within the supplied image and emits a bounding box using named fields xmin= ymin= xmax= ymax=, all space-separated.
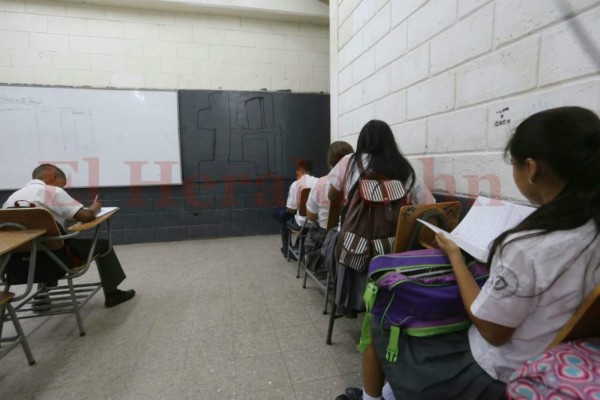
xmin=371 ymin=107 xmax=600 ymax=400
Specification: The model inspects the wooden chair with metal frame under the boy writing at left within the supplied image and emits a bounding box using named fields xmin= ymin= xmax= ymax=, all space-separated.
xmin=0 ymin=207 xmax=108 ymax=336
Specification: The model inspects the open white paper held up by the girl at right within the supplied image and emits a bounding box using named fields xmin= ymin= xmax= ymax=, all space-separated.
xmin=417 ymin=196 xmax=535 ymax=262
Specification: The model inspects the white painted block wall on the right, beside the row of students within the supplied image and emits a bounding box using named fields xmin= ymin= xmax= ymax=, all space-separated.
xmin=330 ymin=0 xmax=600 ymax=199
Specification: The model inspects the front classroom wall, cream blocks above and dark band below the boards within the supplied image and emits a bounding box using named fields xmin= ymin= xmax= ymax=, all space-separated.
xmin=0 ymin=0 xmax=329 ymax=244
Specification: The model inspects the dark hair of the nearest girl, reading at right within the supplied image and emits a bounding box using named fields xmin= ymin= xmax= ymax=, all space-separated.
xmin=488 ymin=107 xmax=600 ymax=265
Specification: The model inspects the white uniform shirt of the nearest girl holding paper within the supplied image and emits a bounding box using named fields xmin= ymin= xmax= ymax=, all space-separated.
xmin=469 ymin=221 xmax=600 ymax=382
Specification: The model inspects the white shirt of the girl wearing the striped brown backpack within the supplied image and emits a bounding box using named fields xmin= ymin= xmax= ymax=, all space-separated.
xmin=328 ymin=154 xmax=435 ymax=204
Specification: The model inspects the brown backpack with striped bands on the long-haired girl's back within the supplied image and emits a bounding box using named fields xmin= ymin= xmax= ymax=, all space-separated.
xmin=336 ymin=175 xmax=407 ymax=272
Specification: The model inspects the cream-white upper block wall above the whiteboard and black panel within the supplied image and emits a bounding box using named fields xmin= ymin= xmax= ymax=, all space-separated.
xmin=0 ymin=0 xmax=329 ymax=92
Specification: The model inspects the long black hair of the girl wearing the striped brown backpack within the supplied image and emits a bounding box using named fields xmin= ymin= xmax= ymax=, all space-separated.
xmin=346 ymin=119 xmax=415 ymax=191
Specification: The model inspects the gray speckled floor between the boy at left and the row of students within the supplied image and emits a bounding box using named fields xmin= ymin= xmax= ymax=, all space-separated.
xmin=0 ymin=236 xmax=361 ymax=400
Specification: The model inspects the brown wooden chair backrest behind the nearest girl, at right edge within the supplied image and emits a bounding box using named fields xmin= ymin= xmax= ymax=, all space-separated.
xmin=548 ymin=285 xmax=600 ymax=348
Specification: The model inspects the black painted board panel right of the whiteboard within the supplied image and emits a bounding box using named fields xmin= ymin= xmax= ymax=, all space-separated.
xmin=179 ymin=90 xmax=330 ymax=182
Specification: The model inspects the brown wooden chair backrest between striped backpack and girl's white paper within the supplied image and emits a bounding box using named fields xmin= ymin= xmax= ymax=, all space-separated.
xmin=394 ymin=201 xmax=461 ymax=253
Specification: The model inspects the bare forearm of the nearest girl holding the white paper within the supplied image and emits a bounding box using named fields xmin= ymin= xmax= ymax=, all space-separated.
xmin=435 ymin=233 xmax=515 ymax=346
